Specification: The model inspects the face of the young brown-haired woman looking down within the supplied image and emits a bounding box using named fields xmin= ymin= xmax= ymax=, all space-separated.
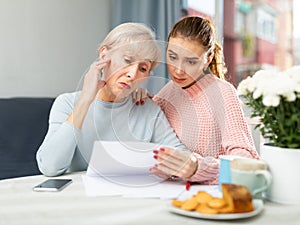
xmin=167 ymin=37 xmax=210 ymax=88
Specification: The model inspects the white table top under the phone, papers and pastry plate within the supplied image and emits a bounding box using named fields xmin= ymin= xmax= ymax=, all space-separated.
xmin=0 ymin=173 xmax=300 ymax=225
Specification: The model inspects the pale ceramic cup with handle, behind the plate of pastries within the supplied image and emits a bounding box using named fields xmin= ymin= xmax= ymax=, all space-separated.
xmin=230 ymin=158 xmax=272 ymax=198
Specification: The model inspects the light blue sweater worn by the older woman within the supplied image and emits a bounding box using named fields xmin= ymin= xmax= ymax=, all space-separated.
xmin=36 ymin=92 xmax=185 ymax=176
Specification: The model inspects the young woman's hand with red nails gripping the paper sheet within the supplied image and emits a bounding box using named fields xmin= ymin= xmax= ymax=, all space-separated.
xmin=150 ymin=148 xmax=198 ymax=179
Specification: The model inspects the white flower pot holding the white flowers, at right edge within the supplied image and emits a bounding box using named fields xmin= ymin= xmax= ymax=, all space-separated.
xmin=260 ymin=144 xmax=300 ymax=204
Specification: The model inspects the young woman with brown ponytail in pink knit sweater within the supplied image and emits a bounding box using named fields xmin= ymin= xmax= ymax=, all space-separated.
xmin=151 ymin=17 xmax=259 ymax=184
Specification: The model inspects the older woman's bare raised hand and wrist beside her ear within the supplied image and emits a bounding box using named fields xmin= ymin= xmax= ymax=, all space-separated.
xmin=81 ymin=59 xmax=110 ymax=102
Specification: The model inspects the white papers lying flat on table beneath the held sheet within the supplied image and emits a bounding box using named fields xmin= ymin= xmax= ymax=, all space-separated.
xmin=82 ymin=175 xmax=222 ymax=200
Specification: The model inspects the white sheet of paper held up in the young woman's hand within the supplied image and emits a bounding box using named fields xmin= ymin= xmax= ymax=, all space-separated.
xmin=87 ymin=141 xmax=160 ymax=176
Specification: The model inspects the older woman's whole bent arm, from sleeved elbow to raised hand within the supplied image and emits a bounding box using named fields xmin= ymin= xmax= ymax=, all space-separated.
xmin=36 ymin=61 xmax=108 ymax=176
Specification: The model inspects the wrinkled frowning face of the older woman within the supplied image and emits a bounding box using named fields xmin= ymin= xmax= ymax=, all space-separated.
xmin=103 ymin=45 xmax=152 ymax=101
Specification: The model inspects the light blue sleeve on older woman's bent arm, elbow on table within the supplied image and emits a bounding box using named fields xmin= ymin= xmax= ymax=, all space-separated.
xmin=36 ymin=92 xmax=80 ymax=176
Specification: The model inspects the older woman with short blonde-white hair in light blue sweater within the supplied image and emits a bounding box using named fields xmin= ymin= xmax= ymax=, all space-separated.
xmin=36 ymin=23 xmax=184 ymax=176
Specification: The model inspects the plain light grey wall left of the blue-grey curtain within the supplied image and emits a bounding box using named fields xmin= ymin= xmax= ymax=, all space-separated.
xmin=0 ymin=0 xmax=111 ymax=98
